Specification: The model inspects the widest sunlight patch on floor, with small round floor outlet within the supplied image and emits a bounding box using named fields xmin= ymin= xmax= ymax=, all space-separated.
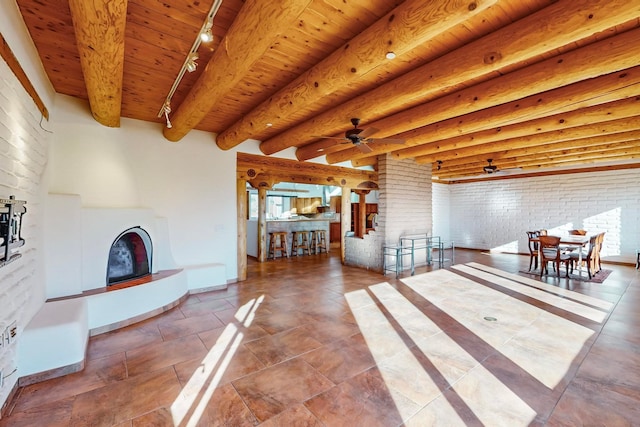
xmin=403 ymin=271 xmax=594 ymax=389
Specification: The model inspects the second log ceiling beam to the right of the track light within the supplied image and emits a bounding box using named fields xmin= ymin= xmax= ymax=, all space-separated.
xmin=216 ymin=0 xmax=496 ymax=150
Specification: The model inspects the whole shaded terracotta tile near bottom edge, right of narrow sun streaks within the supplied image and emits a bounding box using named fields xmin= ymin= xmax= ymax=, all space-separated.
xmin=232 ymin=358 xmax=333 ymax=422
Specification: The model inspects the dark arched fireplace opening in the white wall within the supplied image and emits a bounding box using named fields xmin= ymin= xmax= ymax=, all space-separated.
xmin=107 ymin=227 xmax=153 ymax=286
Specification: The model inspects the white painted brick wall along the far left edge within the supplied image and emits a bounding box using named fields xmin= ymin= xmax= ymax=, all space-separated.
xmin=0 ymin=60 xmax=49 ymax=406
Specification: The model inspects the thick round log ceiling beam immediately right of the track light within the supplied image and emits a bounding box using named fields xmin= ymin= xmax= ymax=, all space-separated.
xmin=164 ymin=0 xmax=311 ymax=142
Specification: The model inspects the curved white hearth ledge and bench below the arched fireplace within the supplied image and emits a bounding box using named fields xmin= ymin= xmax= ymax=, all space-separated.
xmin=18 ymin=264 xmax=227 ymax=386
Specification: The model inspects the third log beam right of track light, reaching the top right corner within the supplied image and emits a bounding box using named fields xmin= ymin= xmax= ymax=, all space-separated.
xmin=260 ymin=0 xmax=638 ymax=154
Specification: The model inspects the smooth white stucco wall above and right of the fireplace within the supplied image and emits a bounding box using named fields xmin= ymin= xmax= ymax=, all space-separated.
xmin=49 ymin=95 xmax=237 ymax=280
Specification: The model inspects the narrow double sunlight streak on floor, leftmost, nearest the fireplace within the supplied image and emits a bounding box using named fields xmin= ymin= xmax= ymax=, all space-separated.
xmin=171 ymin=296 xmax=264 ymax=426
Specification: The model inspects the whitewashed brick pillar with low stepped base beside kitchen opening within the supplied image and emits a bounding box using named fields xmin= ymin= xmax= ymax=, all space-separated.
xmin=345 ymin=155 xmax=432 ymax=271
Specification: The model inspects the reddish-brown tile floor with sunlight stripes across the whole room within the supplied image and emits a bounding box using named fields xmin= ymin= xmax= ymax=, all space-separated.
xmin=0 ymin=250 xmax=640 ymax=427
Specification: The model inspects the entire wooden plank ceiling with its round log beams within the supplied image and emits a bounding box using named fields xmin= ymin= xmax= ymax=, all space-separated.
xmin=16 ymin=0 xmax=640 ymax=181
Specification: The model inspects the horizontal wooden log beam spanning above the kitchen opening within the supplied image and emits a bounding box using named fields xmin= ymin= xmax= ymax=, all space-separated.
xmin=236 ymin=153 xmax=378 ymax=189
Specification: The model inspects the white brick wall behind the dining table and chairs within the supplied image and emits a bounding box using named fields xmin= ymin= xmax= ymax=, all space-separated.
xmin=434 ymin=169 xmax=640 ymax=262
